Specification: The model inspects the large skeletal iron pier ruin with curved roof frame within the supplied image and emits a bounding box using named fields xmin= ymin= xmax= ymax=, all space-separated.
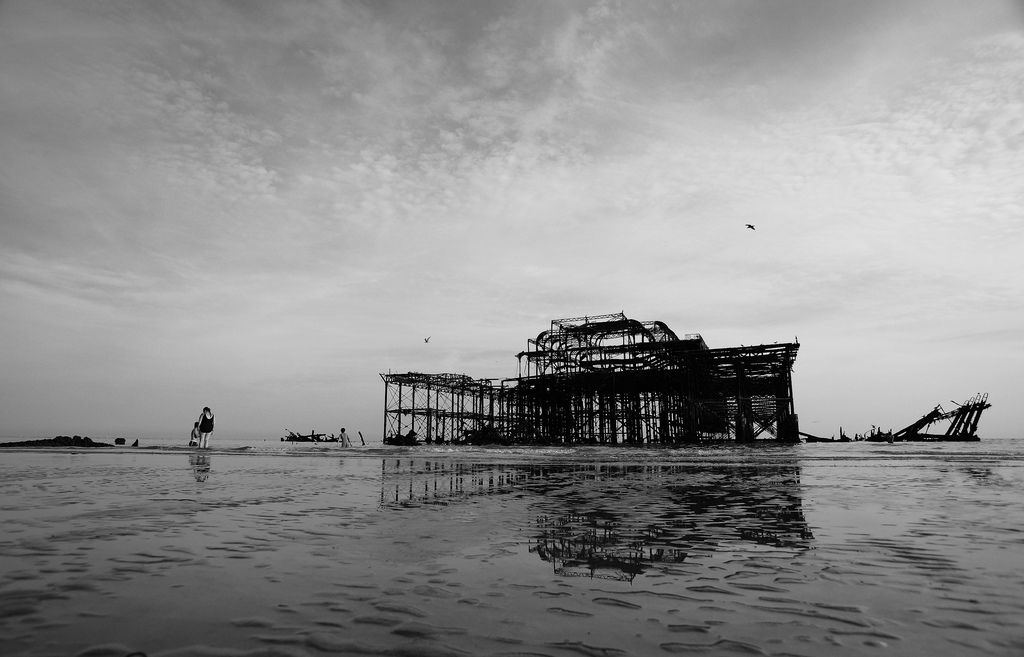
xmin=381 ymin=313 xmax=800 ymax=446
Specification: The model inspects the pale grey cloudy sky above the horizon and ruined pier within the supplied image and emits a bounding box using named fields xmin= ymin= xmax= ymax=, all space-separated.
xmin=0 ymin=0 xmax=1024 ymax=439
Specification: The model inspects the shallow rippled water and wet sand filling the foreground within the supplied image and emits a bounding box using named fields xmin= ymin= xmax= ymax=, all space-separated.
xmin=0 ymin=440 xmax=1024 ymax=657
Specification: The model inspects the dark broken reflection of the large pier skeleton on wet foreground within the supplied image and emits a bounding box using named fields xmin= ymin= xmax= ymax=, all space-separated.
xmin=381 ymin=458 xmax=813 ymax=580
